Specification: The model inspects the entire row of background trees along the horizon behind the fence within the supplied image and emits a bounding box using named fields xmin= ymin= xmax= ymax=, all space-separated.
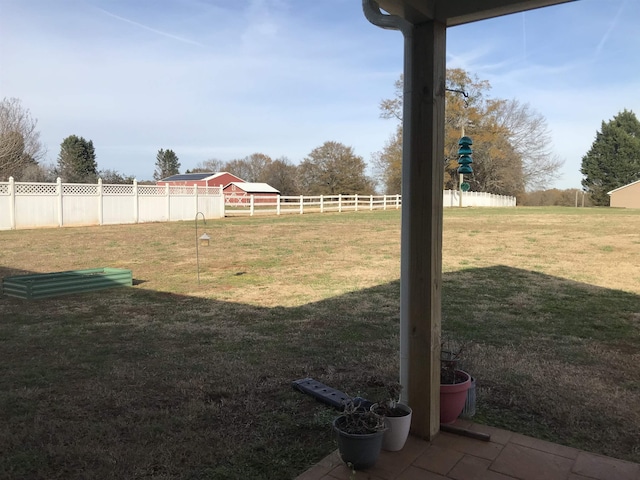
xmin=0 ymin=89 xmax=640 ymax=206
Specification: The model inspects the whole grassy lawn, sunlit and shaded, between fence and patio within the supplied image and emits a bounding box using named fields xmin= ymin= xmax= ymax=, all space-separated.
xmin=0 ymin=208 xmax=640 ymax=479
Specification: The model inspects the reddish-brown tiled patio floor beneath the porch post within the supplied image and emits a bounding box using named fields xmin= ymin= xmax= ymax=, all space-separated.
xmin=296 ymin=421 xmax=640 ymax=480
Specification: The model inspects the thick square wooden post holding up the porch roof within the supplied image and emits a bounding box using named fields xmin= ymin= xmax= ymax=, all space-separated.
xmin=400 ymin=18 xmax=446 ymax=439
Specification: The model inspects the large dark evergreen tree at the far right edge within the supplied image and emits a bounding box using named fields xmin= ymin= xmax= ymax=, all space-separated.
xmin=580 ymin=109 xmax=640 ymax=206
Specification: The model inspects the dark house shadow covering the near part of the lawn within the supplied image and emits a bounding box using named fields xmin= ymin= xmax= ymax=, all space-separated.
xmin=0 ymin=266 xmax=640 ymax=479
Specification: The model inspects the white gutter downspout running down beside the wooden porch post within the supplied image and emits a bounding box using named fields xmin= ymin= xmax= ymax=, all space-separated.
xmin=362 ymin=0 xmax=414 ymax=401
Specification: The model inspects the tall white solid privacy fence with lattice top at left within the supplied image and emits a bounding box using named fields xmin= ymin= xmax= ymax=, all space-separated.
xmin=0 ymin=178 xmax=224 ymax=230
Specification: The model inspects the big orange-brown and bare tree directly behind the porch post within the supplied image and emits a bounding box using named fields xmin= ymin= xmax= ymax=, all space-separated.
xmin=373 ymin=69 xmax=563 ymax=195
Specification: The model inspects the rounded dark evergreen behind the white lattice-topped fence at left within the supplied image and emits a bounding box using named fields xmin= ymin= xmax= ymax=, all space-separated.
xmin=56 ymin=135 xmax=98 ymax=183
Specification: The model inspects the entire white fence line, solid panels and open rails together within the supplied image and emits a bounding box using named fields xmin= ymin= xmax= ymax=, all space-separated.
xmin=0 ymin=179 xmax=516 ymax=230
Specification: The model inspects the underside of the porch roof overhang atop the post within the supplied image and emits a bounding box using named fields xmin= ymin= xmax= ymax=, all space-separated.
xmin=377 ymin=0 xmax=575 ymax=27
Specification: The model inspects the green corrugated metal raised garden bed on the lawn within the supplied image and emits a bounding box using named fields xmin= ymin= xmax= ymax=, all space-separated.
xmin=2 ymin=268 xmax=133 ymax=300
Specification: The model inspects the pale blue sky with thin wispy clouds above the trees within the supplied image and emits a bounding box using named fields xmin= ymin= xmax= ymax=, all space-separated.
xmin=0 ymin=0 xmax=640 ymax=188
